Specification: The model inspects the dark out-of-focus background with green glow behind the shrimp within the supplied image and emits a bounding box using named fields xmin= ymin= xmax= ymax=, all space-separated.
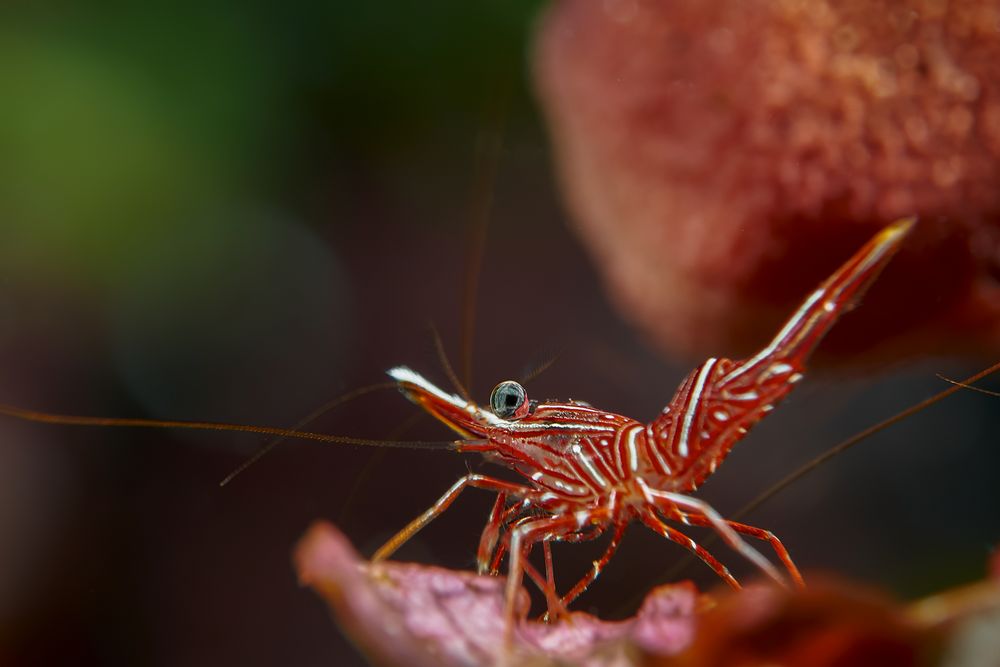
xmin=0 ymin=0 xmax=1000 ymax=665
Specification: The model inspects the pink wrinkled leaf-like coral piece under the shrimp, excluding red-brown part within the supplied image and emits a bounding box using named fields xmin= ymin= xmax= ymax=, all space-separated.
xmin=295 ymin=522 xmax=699 ymax=667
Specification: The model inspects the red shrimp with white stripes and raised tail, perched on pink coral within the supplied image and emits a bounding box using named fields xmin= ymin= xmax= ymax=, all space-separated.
xmin=373 ymin=219 xmax=914 ymax=632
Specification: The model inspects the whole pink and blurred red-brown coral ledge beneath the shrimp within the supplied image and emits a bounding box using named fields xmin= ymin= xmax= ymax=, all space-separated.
xmin=295 ymin=522 xmax=1000 ymax=667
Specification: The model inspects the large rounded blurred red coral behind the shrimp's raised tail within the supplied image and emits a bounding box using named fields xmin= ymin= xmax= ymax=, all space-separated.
xmin=535 ymin=0 xmax=1000 ymax=366
